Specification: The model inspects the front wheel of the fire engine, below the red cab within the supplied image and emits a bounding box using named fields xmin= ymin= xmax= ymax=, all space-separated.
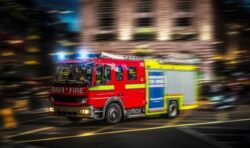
xmin=105 ymin=103 xmax=122 ymax=124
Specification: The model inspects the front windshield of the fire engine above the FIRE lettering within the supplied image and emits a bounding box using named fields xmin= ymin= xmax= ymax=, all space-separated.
xmin=54 ymin=63 xmax=94 ymax=85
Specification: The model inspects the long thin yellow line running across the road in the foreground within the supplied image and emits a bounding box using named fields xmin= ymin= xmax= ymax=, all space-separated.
xmin=13 ymin=118 xmax=250 ymax=143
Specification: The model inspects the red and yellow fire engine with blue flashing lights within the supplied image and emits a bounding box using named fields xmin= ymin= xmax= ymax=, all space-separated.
xmin=50 ymin=53 xmax=198 ymax=124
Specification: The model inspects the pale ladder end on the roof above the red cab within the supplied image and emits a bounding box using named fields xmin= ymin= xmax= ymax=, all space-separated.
xmin=100 ymin=52 xmax=143 ymax=60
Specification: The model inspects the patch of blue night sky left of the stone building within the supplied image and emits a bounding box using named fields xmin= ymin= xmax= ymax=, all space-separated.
xmin=34 ymin=0 xmax=80 ymax=31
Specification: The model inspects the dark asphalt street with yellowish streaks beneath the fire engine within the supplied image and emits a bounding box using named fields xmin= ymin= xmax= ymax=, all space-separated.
xmin=1 ymin=105 xmax=250 ymax=148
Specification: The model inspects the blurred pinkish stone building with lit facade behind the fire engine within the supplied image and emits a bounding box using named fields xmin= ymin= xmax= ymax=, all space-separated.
xmin=82 ymin=0 xmax=215 ymax=79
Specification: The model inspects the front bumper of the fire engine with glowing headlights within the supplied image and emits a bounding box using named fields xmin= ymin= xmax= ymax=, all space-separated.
xmin=50 ymin=105 xmax=94 ymax=118
